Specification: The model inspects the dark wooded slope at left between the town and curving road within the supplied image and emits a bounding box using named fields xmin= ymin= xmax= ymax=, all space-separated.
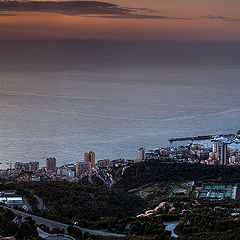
xmin=0 ymin=182 xmax=144 ymax=220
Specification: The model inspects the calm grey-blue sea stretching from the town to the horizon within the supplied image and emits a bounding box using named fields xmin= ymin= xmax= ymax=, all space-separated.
xmin=0 ymin=40 xmax=240 ymax=169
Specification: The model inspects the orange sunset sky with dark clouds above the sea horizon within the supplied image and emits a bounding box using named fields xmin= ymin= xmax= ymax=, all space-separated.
xmin=0 ymin=0 xmax=240 ymax=41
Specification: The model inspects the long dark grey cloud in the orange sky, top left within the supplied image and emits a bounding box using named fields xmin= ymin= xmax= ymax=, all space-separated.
xmin=0 ymin=1 xmax=190 ymax=19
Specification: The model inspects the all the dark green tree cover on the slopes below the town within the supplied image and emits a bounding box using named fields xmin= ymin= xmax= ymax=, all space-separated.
xmin=3 ymin=160 xmax=240 ymax=240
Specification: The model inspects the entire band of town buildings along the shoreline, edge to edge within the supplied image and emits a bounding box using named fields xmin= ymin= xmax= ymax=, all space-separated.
xmin=0 ymin=131 xmax=240 ymax=186
